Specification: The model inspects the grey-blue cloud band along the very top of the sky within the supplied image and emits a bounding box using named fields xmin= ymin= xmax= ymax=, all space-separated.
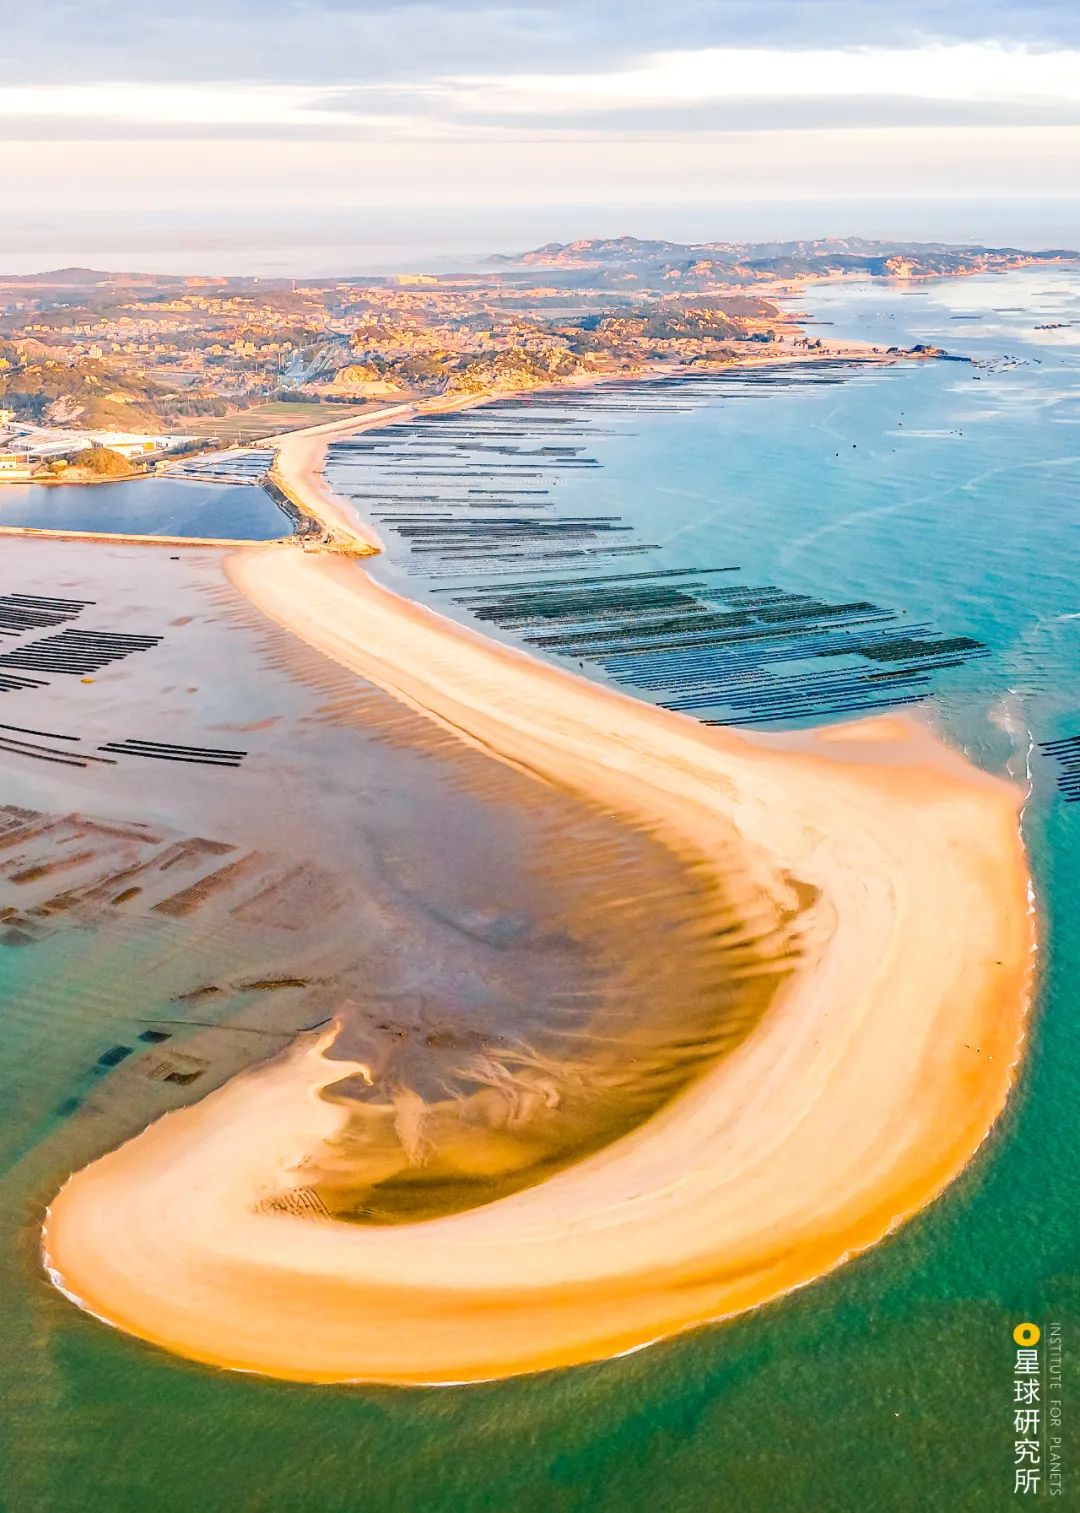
xmin=10 ymin=0 xmax=1080 ymax=85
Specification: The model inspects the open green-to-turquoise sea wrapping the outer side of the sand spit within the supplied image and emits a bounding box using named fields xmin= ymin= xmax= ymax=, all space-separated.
xmin=0 ymin=269 xmax=1080 ymax=1513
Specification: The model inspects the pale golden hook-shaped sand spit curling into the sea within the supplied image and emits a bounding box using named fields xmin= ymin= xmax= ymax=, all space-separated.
xmin=44 ymin=529 xmax=1033 ymax=1384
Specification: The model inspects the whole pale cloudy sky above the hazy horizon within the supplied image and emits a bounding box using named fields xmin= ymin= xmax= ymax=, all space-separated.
xmin=0 ymin=0 xmax=1080 ymax=267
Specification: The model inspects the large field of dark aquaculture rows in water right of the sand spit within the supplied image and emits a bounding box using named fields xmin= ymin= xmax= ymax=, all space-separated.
xmin=322 ymin=365 xmax=986 ymax=725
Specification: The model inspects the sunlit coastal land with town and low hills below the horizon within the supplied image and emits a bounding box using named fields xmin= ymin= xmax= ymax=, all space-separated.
xmin=0 ymin=238 xmax=1065 ymax=483
